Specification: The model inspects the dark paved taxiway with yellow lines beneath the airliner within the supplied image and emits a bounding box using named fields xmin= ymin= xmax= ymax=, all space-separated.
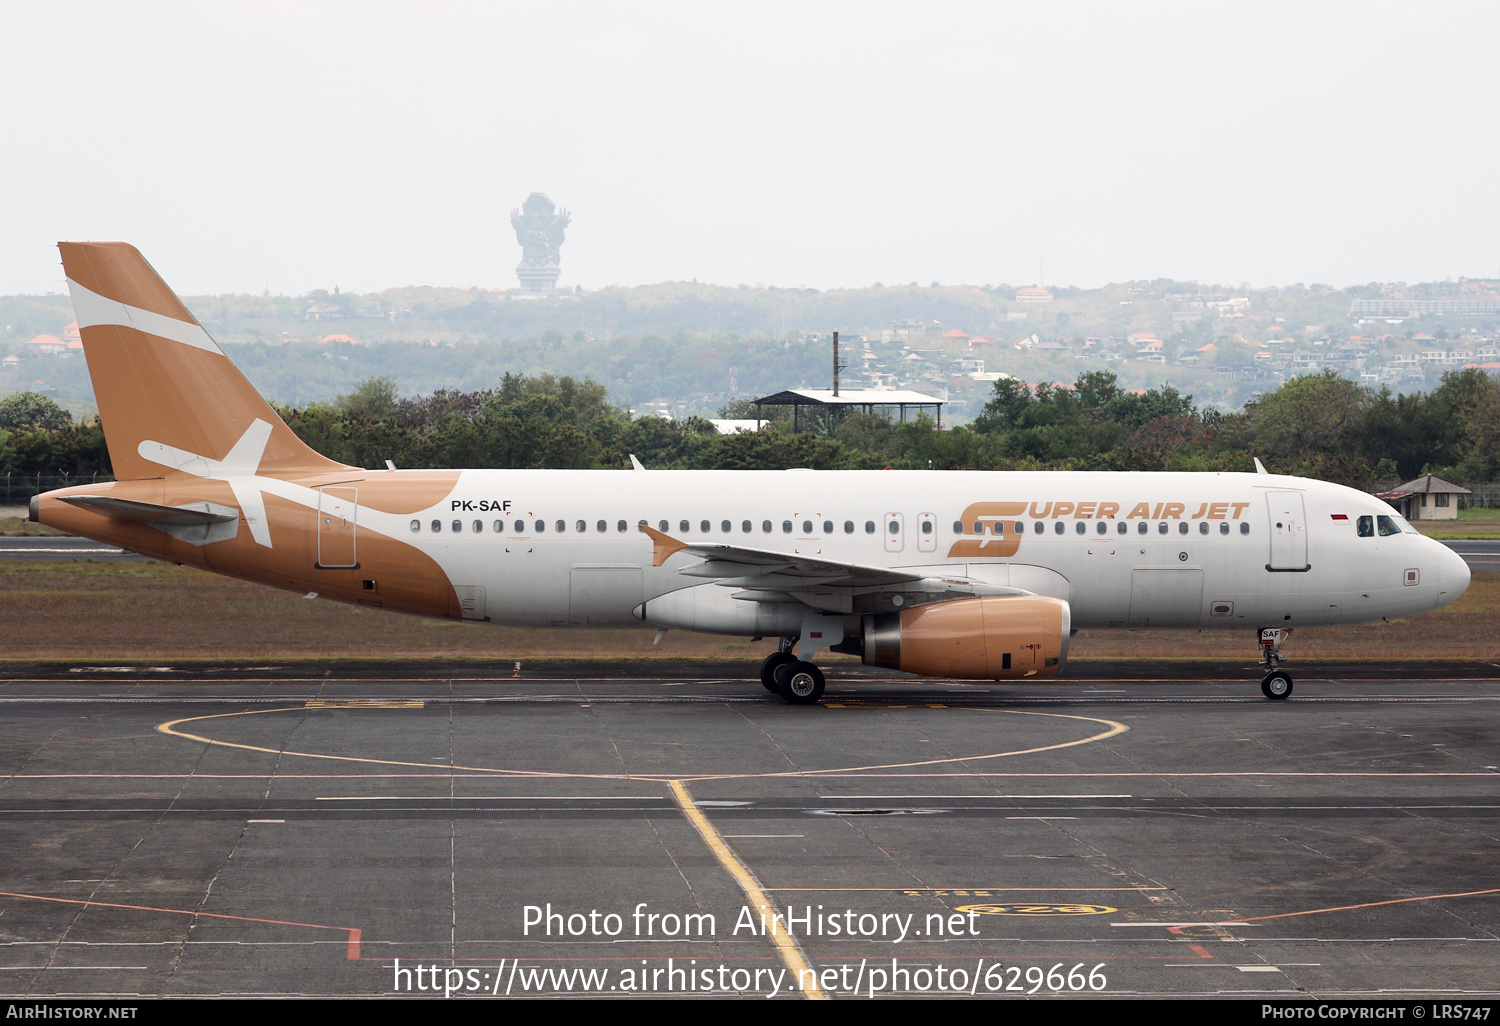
xmin=0 ymin=663 xmax=1500 ymax=998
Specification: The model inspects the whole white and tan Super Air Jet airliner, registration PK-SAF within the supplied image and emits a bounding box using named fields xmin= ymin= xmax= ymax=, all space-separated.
xmin=30 ymin=243 xmax=1469 ymax=705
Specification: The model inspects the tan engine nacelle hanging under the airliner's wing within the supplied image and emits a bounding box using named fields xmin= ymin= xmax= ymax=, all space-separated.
xmin=863 ymin=596 xmax=1073 ymax=681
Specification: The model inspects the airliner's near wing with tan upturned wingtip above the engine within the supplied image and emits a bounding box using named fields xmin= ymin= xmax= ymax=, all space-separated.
xmin=641 ymin=524 xmax=1031 ymax=612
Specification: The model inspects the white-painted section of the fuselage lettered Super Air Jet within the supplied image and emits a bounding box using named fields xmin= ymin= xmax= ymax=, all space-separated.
xmin=381 ymin=471 xmax=1469 ymax=633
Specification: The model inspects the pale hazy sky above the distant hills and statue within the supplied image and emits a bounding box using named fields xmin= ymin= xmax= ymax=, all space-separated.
xmin=0 ymin=0 xmax=1500 ymax=294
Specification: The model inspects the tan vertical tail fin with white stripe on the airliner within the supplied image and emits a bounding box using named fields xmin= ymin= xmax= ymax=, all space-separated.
xmin=57 ymin=243 xmax=354 ymax=482
